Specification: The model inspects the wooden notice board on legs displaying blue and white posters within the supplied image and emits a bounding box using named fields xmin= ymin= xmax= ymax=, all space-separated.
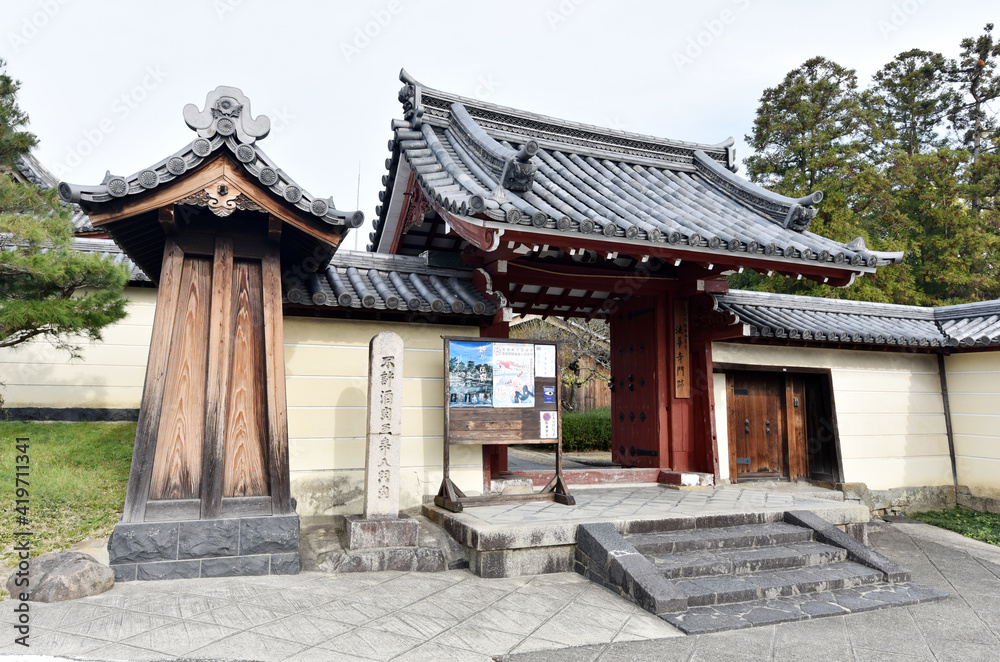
xmin=434 ymin=336 xmax=576 ymax=512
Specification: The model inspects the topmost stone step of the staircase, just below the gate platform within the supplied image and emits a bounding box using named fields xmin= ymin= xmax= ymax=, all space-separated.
xmin=625 ymin=522 xmax=813 ymax=556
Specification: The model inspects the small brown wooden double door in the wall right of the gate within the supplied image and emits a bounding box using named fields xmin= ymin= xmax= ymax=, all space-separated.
xmin=726 ymin=371 xmax=840 ymax=482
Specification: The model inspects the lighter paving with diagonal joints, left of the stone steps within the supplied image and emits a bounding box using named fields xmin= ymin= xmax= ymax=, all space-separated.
xmin=0 ymin=570 xmax=681 ymax=662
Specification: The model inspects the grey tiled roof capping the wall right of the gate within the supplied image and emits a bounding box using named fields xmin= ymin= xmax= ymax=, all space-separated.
xmin=714 ymin=290 xmax=1000 ymax=347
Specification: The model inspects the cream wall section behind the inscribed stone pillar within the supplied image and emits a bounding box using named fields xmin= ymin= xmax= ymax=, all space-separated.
xmin=285 ymin=317 xmax=483 ymax=515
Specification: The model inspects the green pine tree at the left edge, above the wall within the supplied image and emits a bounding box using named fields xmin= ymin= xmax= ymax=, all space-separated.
xmin=0 ymin=60 xmax=128 ymax=364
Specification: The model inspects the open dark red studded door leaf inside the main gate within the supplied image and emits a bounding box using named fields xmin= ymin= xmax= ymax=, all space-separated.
xmin=611 ymin=297 xmax=662 ymax=467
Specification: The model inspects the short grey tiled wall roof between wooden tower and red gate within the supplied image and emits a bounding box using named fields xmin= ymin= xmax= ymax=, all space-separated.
xmin=285 ymin=250 xmax=496 ymax=316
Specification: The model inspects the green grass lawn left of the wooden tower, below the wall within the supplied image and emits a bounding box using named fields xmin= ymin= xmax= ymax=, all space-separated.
xmin=0 ymin=422 xmax=135 ymax=595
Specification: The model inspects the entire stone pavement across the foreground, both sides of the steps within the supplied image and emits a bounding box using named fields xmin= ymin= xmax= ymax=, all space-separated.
xmin=0 ymin=510 xmax=1000 ymax=662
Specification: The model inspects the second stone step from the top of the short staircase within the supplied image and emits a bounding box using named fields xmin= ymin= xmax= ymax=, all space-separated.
xmin=650 ymin=542 xmax=847 ymax=579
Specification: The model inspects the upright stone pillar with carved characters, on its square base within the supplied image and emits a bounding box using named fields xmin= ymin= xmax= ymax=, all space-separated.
xmin=344 ymin=331 xmax=418 ymax=550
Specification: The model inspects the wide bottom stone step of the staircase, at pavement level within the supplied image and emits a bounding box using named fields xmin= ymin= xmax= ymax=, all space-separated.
xmin=660 ymin=583 xmax=948 ymax=634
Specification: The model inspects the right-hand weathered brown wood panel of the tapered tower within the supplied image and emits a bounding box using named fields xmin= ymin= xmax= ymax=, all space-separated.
xmin=223 ymin=260 xmax=268 ymax=497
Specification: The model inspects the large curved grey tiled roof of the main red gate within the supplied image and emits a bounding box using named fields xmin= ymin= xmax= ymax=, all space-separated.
xmin=370 ymin=72 xmax=902 ymax=278
